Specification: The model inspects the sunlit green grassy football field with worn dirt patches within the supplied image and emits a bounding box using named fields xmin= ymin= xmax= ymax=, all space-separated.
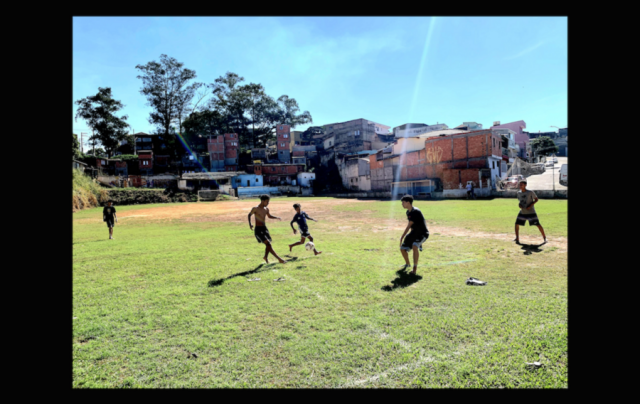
xmin=72 ymin=198 xmax=568 ymax=388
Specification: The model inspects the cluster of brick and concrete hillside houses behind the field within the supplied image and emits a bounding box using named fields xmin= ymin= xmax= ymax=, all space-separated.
xmin=74 ymin=119 xmax=567 ymax=197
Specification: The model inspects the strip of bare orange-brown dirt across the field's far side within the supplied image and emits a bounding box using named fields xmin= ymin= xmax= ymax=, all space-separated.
xmin=104 ymin=199 xmax=567 ymax=251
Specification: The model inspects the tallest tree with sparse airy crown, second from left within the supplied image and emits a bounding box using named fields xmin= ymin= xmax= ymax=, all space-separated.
xmin=136 ymin=54 xmax=201 ymax=157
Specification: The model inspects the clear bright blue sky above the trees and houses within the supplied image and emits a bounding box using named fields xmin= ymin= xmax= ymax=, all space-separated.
xmin=72 ymin=17 xmax=568 ymax=148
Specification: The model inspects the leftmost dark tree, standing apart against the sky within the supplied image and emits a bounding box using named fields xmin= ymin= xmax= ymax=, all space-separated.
xmin=75 ymin=87 xmax=129 ymax=157
